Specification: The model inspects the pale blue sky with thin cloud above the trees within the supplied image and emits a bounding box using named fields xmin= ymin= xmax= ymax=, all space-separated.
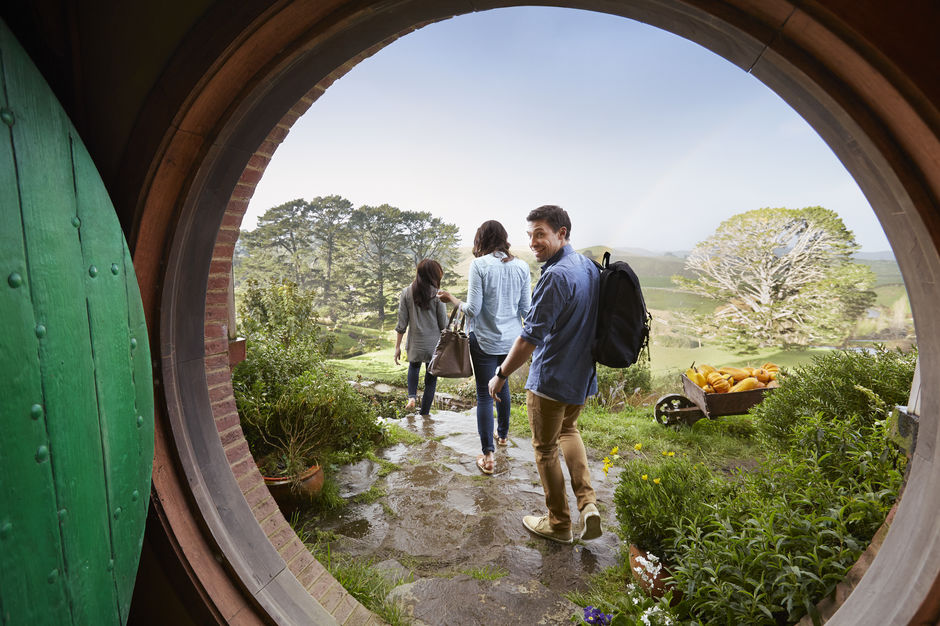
xmin=243 ymin=7 xmax=889 ymax=251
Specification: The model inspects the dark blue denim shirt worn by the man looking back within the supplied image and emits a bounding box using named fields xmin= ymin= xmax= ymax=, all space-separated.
xmin=521 ymin=244 xmax=600 ymax=404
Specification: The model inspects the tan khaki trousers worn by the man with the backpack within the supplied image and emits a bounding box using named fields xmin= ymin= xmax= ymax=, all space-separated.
xmin=526 ymin=391 xmax=595 ymax=531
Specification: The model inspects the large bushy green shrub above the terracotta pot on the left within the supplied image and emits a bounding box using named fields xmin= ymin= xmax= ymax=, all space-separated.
xmin=232 ymin=282 xmax=385 ymax=476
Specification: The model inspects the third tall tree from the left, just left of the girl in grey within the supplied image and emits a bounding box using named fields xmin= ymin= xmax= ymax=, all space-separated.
xmin=344 ymin=204 xmax=414 ymax=327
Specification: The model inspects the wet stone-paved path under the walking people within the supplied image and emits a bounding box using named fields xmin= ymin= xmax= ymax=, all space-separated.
xmin=310 ymin=410 xmax=619 ymax=626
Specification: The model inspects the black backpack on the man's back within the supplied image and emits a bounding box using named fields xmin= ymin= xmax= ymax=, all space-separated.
xmin=591 ymin=252 xmax=653 ymax=367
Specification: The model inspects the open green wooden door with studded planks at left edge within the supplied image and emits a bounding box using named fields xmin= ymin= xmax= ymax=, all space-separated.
xmin=0 ymin=22 xmax=153 ymax=625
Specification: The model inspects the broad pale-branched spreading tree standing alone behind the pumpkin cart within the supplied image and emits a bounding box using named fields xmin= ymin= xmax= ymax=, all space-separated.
xmin=673 ymin=207 xmax=875 ymax=352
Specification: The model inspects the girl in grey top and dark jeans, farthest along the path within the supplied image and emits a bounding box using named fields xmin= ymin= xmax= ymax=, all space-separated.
xmin=395 ymin=259 xmax=447 ymax=417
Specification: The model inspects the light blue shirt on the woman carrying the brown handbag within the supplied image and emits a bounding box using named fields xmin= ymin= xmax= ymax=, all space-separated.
xmin=462 ymin=252 xmax=532 ymax=355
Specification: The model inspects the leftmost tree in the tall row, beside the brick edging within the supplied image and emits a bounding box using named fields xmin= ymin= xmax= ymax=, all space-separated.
xmin=240 ymin=199 xmax=316 ymax=289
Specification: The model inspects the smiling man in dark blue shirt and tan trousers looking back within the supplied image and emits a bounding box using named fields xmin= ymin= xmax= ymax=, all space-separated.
xmin=489 ymin=205 xmax=601 ymax=543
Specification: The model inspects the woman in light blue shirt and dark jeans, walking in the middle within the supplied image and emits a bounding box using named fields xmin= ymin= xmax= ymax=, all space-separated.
xmin=438 ymin=220 xmax=532 ymax=474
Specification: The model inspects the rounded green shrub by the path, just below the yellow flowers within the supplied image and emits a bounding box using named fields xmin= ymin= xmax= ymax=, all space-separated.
xmin=614 ymin=453 xmax=720 ymax=560
